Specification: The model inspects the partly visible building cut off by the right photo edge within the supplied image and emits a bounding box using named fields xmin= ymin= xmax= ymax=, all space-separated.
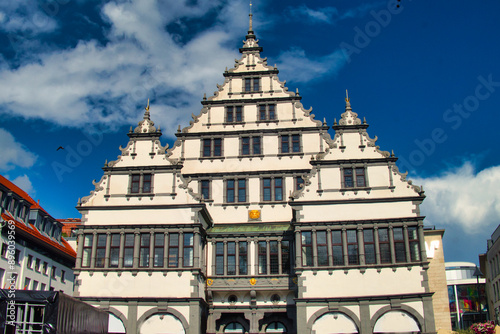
xmin=479 ymin=225 xmax=500 ymax=324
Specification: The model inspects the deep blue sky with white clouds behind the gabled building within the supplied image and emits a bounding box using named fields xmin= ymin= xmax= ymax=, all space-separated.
xmin=0 ymin=0 xmax=500 ymax=263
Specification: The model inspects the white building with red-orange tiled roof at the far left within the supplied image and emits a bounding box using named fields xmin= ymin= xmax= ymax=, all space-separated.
xmin=0 ymin=175 xmax=76 ymax=295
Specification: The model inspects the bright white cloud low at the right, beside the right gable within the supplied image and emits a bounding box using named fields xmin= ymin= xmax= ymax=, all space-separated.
xmin=414 ymin=162 xmax=500 ymax=234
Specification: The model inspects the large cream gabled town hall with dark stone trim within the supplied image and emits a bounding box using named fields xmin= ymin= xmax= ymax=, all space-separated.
xmin=75 ymin=11 xmax=439 ymax=334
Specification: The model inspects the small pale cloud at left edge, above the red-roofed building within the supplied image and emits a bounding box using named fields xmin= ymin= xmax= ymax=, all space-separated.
xmin=0 ymin=128 xmax=37 ymax=171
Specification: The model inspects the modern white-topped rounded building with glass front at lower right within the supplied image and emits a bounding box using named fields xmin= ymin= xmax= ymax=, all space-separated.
xmin=445 ymin=262 xmax=488 ymax=330
